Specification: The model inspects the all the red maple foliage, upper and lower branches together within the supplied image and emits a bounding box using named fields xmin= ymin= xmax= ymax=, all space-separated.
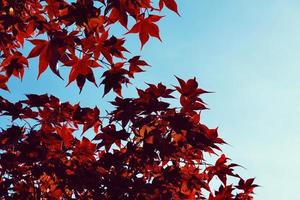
xmin=0 ymin=0 xmax=257 ymax=200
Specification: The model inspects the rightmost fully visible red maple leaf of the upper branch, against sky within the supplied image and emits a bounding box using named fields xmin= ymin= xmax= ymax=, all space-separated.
xmin=126 ymin=15 xmax=163 ymax=49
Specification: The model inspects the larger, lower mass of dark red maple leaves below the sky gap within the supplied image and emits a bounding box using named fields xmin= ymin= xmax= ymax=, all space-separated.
xmin=0 ymin=78 xmax=257 ymax=200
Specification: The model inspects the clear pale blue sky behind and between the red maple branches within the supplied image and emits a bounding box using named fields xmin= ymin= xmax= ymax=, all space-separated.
xmin=0 ymin=0 xmax=300 ymax=200
